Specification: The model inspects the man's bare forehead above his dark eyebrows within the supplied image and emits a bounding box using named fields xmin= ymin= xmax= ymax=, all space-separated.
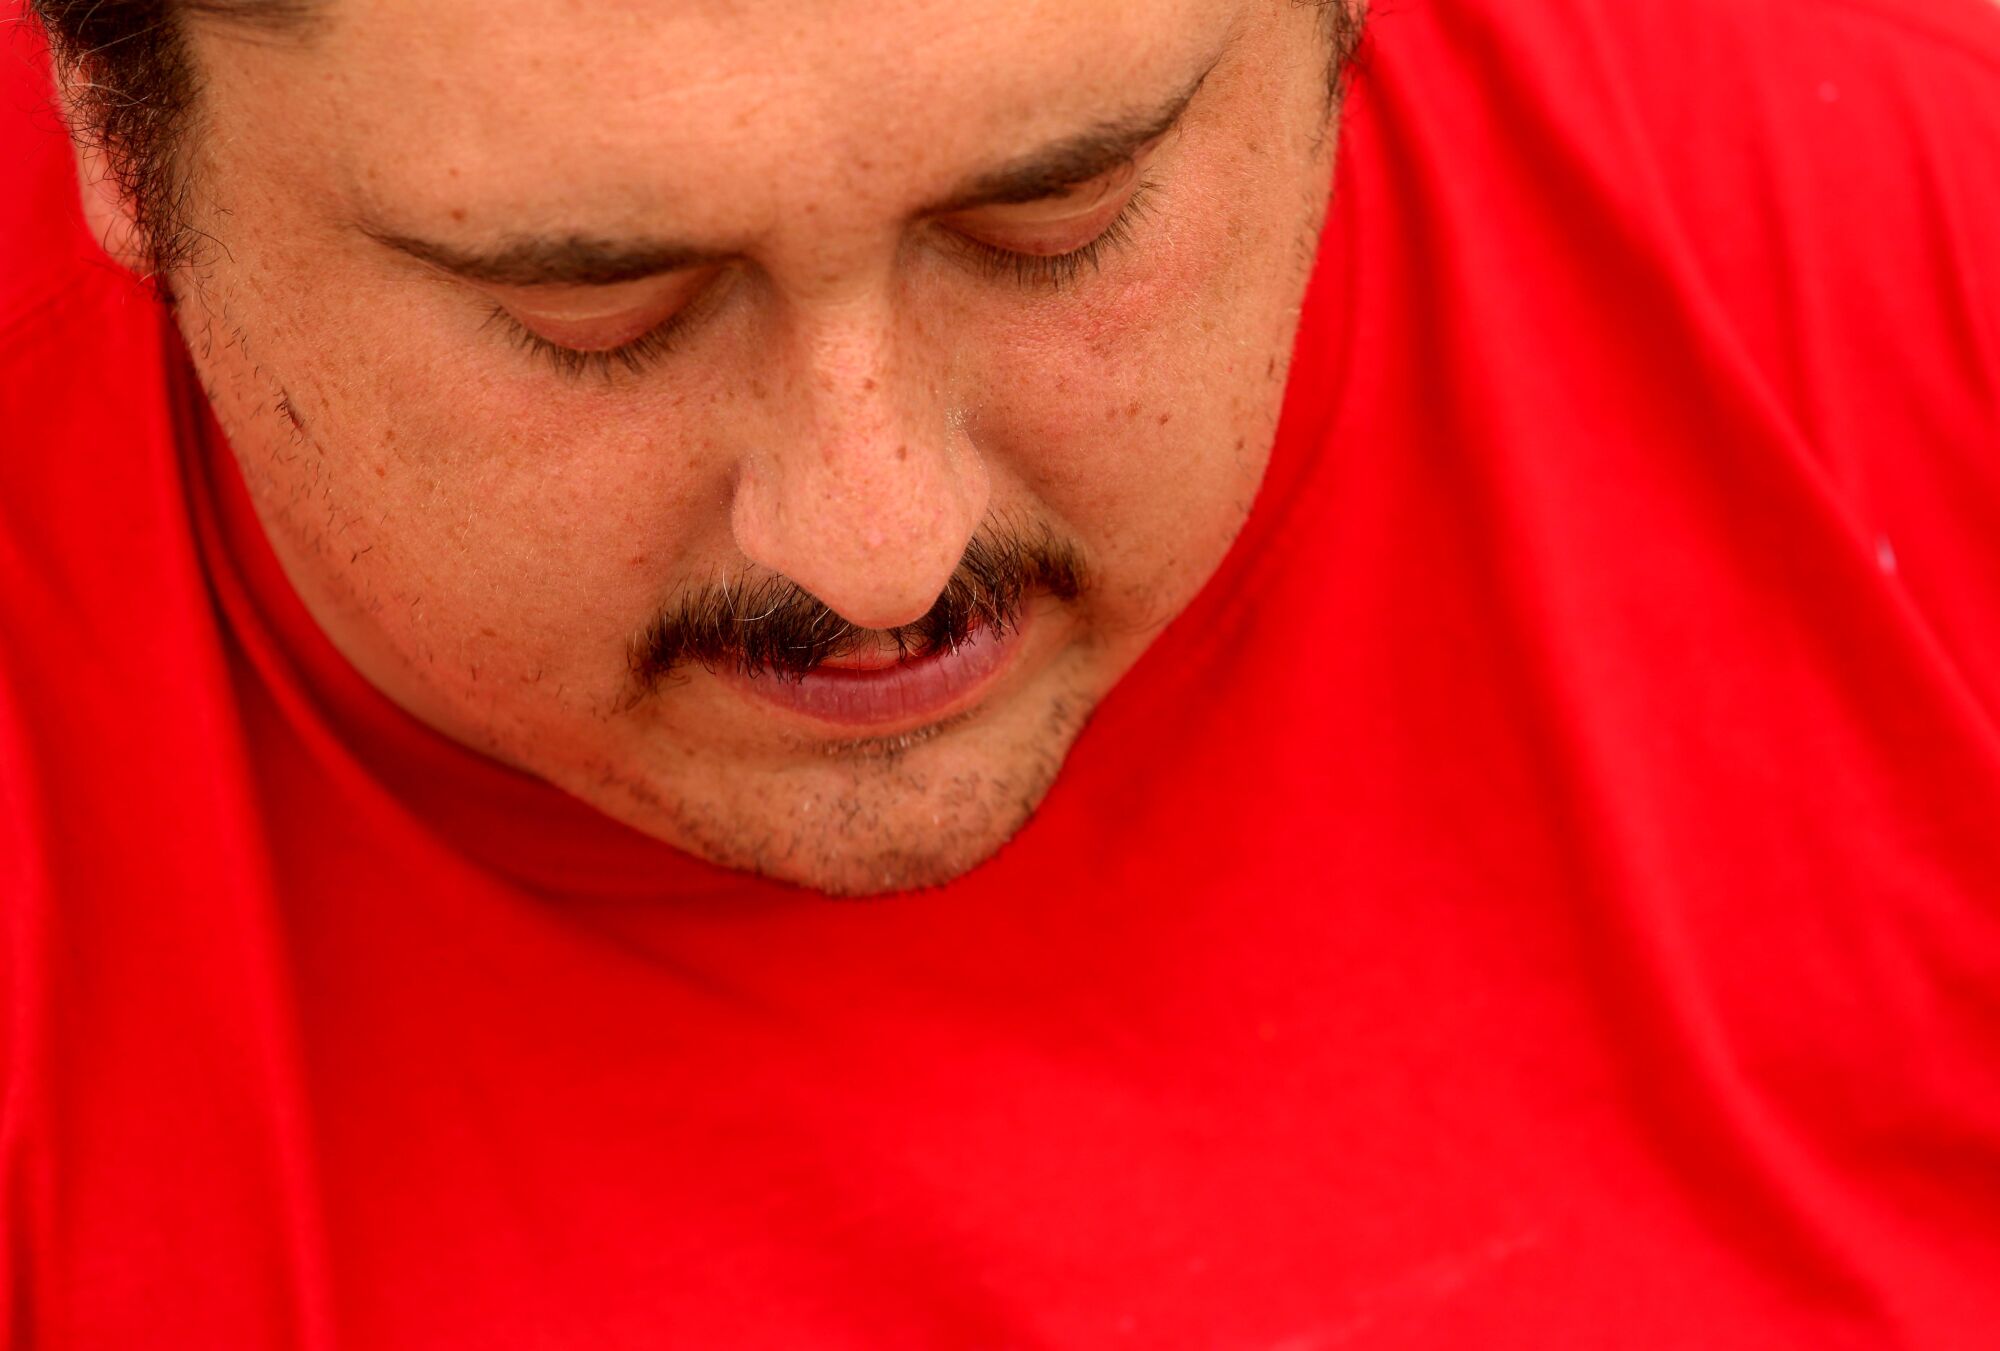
xmin=198 ymin=0 xmax=1244 ymax=224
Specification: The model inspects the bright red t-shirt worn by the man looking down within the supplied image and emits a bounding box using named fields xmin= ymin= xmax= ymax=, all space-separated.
xmin=0 ymin=0 xmax=2000 ymax=1351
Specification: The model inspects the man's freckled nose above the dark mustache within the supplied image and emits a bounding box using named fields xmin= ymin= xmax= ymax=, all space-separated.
xmin=730 ymin=298 xmax=990 ymax=630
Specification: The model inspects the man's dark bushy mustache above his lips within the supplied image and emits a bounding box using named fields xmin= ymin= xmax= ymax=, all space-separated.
xmin=626 ymin=530 xmax=1088 ymax=695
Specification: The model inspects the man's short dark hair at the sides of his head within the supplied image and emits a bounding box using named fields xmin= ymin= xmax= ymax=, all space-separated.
xmin=30 ymin=0 xmax=1364 ymax=276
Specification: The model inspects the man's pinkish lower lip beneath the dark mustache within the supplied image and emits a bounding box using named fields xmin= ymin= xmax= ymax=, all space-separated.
xmin=730 ymin=626 xmax=1020 ymax=727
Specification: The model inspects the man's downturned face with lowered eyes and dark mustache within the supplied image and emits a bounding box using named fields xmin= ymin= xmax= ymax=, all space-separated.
xmin=172 ymin=0 xmax=1332 ymax=893
